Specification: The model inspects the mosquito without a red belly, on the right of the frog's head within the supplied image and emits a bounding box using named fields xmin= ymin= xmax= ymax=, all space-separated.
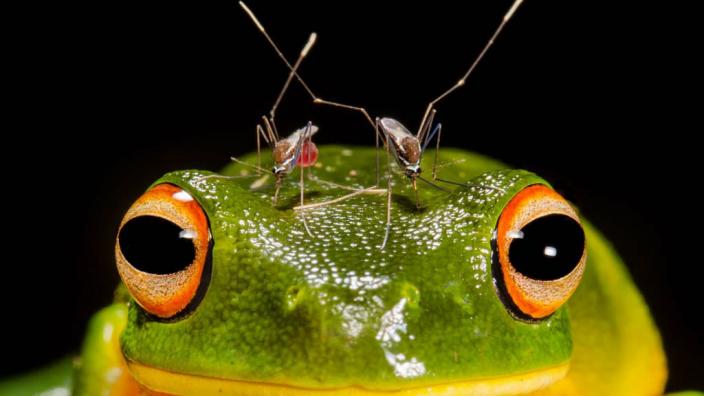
xmin=240 ymin=0 xmax=523 ymax=250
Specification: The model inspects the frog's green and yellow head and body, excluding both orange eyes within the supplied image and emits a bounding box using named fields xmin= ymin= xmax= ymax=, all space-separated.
xmin=0 ymin=146 xmax=680 ymax=395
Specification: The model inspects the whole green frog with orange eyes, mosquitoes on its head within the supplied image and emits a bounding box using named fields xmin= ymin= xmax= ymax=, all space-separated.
xmin=0 ymin=145 xmax=701 ymax=396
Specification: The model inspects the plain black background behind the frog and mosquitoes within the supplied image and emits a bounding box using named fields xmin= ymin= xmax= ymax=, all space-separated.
xmin=0 ymin=0 xmax=704 ymax=389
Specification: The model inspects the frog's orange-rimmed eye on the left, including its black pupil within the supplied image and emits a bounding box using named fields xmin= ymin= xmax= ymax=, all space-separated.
xmin=115 ymin=184 xmax=211 ymax=319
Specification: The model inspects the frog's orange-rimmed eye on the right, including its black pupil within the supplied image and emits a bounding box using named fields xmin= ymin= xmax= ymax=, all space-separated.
xmin=494 ymin=185 xmax=587 ymax=319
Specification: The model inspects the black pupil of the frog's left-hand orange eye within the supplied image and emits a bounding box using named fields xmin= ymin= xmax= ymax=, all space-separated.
xmin=120 ymin=216 xmax=196 ymax=275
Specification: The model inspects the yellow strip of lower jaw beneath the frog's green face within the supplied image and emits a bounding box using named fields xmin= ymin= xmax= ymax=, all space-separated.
xmin=127 ymin=361 xmax=569 ymax=396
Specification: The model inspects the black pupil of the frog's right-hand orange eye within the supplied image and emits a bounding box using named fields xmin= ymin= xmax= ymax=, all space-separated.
xmin=508 ymin=214 xmax=584 ymax=280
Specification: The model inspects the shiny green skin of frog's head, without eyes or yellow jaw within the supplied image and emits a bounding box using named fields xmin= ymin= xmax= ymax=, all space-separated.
xmin=121 ymin=146 xmax=572 ymax=389
